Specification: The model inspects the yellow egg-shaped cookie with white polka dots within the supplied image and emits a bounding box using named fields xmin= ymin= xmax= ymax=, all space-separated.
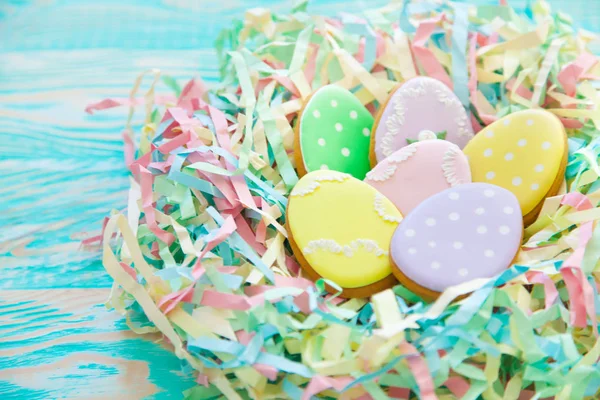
xmin=464 ymin=110 xmax=568 ymax=226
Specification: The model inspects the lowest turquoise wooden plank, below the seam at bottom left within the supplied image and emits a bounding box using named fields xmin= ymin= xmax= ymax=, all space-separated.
xmin=0 ymin=289 xmax=193 ymax=399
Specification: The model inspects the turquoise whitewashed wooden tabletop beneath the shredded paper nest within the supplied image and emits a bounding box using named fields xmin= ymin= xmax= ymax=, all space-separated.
xmin=0 ymin=0 xmax=600 ymax=399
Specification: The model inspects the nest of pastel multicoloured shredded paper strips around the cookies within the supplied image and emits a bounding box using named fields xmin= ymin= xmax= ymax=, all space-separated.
xmin=95 ymin=1 xmax=600 ymax=399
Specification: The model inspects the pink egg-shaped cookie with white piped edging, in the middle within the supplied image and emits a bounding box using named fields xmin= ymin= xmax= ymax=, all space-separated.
xmin=365 ymin=139 xmax=471 ymax=215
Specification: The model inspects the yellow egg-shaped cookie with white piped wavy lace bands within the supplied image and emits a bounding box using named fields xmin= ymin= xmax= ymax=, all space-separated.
xmin=287 ymin=170 xmax=402 ymax=297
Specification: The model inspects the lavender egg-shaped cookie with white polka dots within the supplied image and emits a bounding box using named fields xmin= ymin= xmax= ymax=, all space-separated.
xmin=390 ymin=183 xmax=523 ymax=299
